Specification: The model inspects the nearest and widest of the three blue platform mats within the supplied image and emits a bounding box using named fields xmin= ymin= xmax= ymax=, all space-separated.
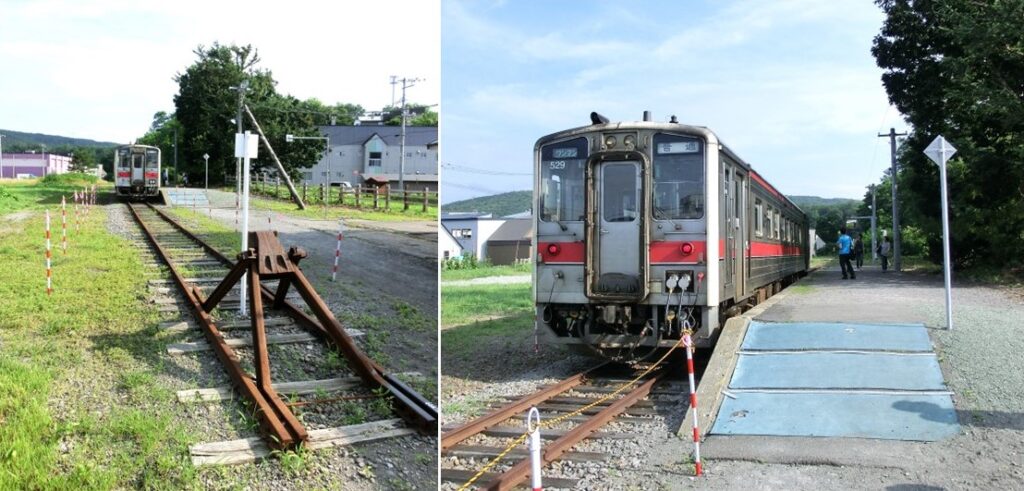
xmin=712 ymin=393 xmax=959 ymax=442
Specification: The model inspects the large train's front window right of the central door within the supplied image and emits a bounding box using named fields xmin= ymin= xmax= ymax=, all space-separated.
xmin=653 ymin=133 xmax=705 ymax=220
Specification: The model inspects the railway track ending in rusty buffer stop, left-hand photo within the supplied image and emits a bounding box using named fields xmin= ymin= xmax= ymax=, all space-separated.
xmin=128 ymin=204 xmax=437 ymax=464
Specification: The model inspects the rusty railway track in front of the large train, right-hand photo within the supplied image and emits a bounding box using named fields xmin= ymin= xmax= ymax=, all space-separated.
xmin=441 ymin=364 xmax=689 ymax=490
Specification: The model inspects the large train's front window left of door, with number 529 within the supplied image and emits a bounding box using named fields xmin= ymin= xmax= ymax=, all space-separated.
xmin=539 ymin=138 xmax=587 ymax=221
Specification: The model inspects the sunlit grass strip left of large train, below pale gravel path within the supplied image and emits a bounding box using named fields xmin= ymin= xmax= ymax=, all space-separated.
xmin=441 ymin=283 xmax=534 ymax=328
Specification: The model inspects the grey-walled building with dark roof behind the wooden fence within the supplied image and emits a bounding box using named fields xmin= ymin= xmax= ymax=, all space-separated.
xmin=301 ymin=124 xmax=437 ymax=191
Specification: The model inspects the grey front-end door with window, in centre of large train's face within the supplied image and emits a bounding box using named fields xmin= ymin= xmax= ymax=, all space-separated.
xmin=592 ymin=161 xmax=643 ymax=295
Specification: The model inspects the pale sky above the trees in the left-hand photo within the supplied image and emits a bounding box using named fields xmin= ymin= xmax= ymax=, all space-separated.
xmin=0 ymin=0 xmax=440 ymax=142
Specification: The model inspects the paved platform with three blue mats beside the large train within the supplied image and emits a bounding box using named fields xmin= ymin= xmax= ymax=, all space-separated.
xmin=679 ymin=261 xmax=961 ymax=465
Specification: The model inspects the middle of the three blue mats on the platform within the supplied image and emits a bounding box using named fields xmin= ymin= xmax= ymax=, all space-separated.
xmin=729 ymin=352 xmax=946 ymax=391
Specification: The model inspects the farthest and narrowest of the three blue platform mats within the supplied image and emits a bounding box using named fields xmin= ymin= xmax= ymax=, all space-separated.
xmin=742 ymin=321 xmax=932 ymax=352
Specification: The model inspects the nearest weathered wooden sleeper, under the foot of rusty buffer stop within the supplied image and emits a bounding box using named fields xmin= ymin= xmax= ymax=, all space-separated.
xmin=188 ymin=419 xmax=416 ymax=466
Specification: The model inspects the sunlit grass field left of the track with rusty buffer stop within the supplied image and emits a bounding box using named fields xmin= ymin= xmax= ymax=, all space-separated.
xmin=0 ymin=182 xmax=197 ymax=490
